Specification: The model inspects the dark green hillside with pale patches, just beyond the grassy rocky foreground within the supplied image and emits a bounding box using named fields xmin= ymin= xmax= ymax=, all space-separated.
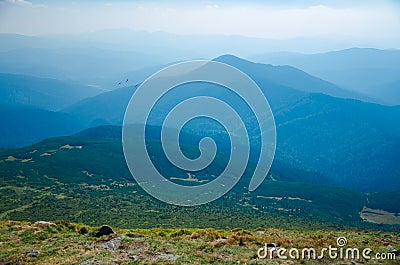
xmin=0 ymin=127 xmax=390 ymax=229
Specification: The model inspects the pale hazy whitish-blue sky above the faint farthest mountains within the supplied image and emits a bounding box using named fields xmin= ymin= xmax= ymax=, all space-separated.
xmin=0 ymin=0 xmax=400 ymax=39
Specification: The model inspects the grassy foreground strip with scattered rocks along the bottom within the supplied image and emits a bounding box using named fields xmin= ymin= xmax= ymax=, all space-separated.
xmin=0 ymin=221 xmax=400 ymax=265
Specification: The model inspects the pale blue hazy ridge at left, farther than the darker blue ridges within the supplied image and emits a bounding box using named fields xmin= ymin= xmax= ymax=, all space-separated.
xmin=0 ymin=46 xmax=168 ymax=86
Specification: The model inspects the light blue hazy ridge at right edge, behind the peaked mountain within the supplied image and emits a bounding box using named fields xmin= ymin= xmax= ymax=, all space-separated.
xmin=249 ymin=48 xmax=400 ymax=105
